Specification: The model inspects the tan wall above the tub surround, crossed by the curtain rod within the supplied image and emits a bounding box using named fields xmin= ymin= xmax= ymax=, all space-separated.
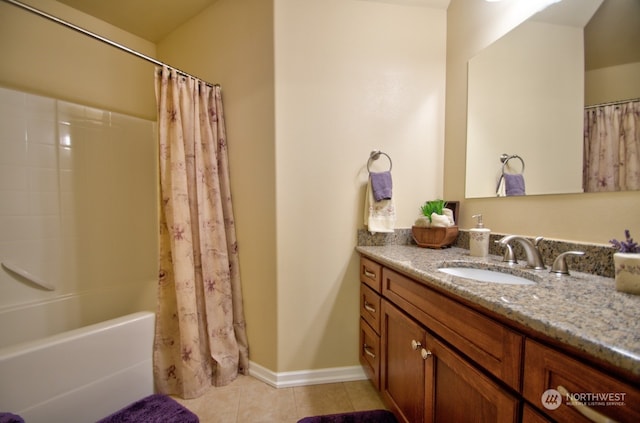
xmin=0 ymin=0 xmax=156 ymax=120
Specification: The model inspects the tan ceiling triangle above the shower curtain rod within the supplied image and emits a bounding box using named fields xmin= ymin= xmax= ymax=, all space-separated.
xmin=58 ymin=0 xmax=217 ymax=43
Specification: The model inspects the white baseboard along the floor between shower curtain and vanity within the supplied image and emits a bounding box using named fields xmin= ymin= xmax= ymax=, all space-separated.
xmin=249 ymin=361 xmax=367 ymax=388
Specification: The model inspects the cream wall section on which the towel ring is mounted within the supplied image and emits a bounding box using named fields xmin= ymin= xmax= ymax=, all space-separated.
xmin=275 ymin=0 xmax=446 ymax=371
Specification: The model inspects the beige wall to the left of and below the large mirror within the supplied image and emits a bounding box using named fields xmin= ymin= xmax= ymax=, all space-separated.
xmin=444 ymin=0 xmax=640 ymax=244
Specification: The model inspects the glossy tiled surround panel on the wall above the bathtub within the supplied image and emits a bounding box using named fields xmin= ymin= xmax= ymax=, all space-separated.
xmin=0 ymin=87 xmax=157 ymax=347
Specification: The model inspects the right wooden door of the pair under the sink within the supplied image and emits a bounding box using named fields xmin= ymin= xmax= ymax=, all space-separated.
xmin=423 ymin=334 xmax=519 ymax=423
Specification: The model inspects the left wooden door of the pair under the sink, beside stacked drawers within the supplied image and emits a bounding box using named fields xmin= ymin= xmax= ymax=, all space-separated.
xmin=381 ymin=300 xmax=426 ymax=423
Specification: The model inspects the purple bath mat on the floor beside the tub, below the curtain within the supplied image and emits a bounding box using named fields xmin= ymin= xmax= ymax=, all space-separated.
xmin=97 ymin=394 xmax=199 ymax=423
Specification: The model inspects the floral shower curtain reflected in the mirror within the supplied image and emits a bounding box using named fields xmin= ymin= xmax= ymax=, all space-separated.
xmin=582 ymin=100 xmax=640 ymax=192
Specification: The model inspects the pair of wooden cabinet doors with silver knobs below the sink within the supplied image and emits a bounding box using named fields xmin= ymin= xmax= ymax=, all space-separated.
xmin=381 ymin=300 xmax=520 ymax=423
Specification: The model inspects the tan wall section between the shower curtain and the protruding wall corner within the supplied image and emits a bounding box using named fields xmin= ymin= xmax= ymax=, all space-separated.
xmin=157 ymin=0 xmax=279 ymax=370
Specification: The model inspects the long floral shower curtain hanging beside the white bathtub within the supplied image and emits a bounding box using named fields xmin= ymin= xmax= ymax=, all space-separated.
xmin=153 ymin=67 xmax=249 ymax=398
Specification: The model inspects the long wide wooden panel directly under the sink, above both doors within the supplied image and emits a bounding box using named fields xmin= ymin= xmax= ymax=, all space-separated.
xmin=382 ymin=268 xmax=524 ymax=392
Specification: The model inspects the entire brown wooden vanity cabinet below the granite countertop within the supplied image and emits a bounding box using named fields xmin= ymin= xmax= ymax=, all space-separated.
xmin=360 ymin=257 xmax=640 ymax=423
